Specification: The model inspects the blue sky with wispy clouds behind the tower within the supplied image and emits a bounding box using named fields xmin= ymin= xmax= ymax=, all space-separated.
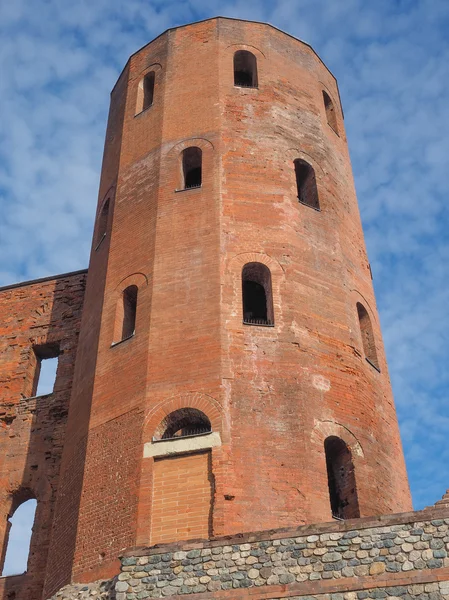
xmin=0 ymin=0 xmax=449 ymax=572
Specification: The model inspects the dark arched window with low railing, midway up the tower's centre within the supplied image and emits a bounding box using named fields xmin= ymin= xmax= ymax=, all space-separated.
xmin=242 ymin=262 xmax=274 ymax=325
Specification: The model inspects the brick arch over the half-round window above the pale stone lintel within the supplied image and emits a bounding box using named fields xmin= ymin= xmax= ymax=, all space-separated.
xmin=142 ymin=392 xmax=223 ymax=443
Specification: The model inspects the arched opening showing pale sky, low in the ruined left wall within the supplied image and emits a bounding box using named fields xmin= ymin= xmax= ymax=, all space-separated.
xmin=2 ymin=490 xmax=37 ymax=577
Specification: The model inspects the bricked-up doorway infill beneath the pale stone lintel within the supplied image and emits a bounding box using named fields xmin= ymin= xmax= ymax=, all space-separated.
xmin=150 ymin=452 xmax=212 ymax=544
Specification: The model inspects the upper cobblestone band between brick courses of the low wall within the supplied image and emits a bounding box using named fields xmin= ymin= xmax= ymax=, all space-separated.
xmin=116 ymin=519 xmax=449 ymax=600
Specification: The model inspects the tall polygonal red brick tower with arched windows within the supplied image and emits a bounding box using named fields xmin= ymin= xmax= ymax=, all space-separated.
xmin=34 ymin=18 xmax=411 ymax=597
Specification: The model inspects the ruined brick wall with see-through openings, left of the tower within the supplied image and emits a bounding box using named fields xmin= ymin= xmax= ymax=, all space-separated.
xmin=0 ymin=271 xmax=86 ymax=600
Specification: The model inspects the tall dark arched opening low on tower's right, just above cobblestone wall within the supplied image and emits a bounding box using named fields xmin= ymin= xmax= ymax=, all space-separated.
xmin=324 ymin=436 xmax=360 ymax=519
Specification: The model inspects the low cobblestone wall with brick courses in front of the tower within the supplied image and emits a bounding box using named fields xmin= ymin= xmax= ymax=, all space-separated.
xmin=46 ymin=496 xmax=449 ymax=600
